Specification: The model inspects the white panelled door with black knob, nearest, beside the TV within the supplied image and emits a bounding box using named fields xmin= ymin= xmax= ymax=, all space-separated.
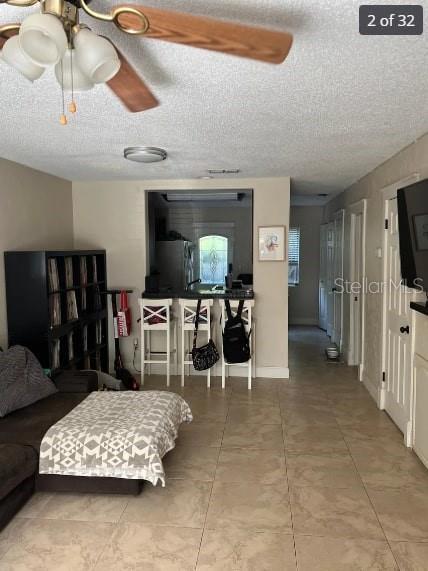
xmin=381 ymin=197 xmax=416 ymax=446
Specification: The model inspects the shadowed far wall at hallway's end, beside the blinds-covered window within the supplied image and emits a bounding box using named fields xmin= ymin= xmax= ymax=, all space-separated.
xmin=288 ymin=206 xmax=323 ymax=325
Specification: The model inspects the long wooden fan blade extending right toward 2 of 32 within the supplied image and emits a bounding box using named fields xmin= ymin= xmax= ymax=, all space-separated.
xmin=118 ymin=4 xmax=293 ymax=63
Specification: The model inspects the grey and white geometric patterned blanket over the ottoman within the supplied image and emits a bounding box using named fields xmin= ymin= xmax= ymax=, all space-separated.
xmin=39 ymin=391 xmax=193 ymax=486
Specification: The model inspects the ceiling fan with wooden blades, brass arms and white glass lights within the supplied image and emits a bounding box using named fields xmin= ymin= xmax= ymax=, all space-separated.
xmin=0 ymin=0 xmax=293 ymax=124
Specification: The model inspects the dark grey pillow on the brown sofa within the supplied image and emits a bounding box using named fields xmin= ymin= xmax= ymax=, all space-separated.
xmin=0 ymin=345 xmax=57 ymax=418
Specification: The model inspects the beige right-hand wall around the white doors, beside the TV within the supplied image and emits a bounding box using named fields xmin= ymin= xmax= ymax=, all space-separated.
xmin=324 ymin=134 xmax=428 ymax=402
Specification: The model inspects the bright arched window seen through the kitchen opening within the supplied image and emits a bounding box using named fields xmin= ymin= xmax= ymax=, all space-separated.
xmin=199 ymin=236 xmax=229 ymax=284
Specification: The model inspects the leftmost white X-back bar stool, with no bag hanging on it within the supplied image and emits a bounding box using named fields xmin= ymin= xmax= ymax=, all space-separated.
xmin=138 ymin=298 xmax=178 ymax=387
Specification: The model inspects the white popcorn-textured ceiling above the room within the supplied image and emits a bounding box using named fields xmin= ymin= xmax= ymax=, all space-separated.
xmin=0 ymin=0 xmax=428 ymax=201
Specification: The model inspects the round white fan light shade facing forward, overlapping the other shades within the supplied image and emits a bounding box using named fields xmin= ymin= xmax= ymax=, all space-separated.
xmin=19 ymin=14 xmax=68 ymax=67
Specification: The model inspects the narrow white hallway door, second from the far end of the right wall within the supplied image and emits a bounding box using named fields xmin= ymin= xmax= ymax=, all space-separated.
xmin=331 ymin=210 xmax=345 ymax=351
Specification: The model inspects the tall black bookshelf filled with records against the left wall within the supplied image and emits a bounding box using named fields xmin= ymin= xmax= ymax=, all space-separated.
xmin=4 ymin=250 xmax=109 ymax=375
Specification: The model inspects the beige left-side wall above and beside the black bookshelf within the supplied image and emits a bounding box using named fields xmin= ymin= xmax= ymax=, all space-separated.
xmin=0 ymin=159 xmax=73 ymax=347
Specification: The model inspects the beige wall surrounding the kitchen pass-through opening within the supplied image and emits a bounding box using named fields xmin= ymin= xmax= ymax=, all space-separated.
xmin=73 ymin=177 xmax=290 ymax=377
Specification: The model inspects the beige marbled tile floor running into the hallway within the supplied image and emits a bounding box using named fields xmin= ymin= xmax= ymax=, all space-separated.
xmin=0 ymin=328 xmax=428 ymax=571
